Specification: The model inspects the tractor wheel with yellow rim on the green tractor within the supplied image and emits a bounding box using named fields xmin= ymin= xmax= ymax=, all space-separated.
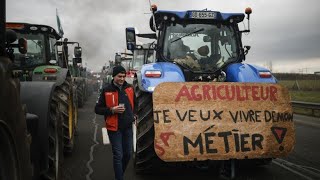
xmin=57 ymin=78 xmax=75 ymax=154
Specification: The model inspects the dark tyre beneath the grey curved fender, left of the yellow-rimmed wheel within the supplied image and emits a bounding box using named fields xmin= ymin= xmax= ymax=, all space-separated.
xmin=44 ymin=91 xmax=63 ymax=180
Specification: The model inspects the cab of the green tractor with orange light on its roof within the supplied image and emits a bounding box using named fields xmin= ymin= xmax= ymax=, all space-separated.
xmin=6 ymin=23 xmax=81 ymax=81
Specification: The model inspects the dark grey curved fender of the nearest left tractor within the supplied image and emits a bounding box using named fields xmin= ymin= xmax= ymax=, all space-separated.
xmin=20 ymin=81 xmax=56 ymax=171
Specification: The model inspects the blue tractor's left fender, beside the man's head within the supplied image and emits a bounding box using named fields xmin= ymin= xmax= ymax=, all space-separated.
xmin=137 ymin=62 xmax=186 ymax=92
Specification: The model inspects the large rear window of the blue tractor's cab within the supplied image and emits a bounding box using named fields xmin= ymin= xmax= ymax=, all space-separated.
xmin=163 ymin=23 xmax=239 ymax=72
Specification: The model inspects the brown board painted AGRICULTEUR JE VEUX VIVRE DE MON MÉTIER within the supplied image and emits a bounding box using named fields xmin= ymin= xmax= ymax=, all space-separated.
xmin=153 ymin=82 xmax=295 ymax=161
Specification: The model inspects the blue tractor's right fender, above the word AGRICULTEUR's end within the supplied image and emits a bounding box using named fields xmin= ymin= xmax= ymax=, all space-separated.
xmin=226 ymin=63 xmax=277 ymax=83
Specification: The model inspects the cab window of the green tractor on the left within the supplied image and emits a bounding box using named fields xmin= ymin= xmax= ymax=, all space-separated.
xmin=14 ymin=33 xmax=46 ymax=68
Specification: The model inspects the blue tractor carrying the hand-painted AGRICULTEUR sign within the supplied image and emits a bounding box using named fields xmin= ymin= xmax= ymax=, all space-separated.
xmin=126 ymin=6 xmax=292 ymax=177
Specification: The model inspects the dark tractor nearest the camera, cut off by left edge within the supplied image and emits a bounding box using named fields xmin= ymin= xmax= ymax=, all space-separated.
xmin=0 ymin=1 xmax=63 ymax=180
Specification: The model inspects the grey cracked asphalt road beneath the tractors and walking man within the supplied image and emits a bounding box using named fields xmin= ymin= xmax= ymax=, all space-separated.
xmin=62 ymin=93 xmax=320 ymax=180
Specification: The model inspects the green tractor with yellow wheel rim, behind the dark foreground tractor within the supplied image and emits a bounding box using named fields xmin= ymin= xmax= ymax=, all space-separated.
xmin=6 ymin=23 xmax=78 ymax=157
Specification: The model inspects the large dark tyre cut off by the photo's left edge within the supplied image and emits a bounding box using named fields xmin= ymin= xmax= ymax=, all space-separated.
xmin=0 ymin=57 xmax=32 ymax=180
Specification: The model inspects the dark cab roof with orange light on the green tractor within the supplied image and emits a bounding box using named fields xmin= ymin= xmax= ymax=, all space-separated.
xmin=6 ymin=22 xmax=61 ymax=40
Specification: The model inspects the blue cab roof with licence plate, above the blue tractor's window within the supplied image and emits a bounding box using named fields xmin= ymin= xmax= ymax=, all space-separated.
xmin=155 ymin=10 xmax=245 ymax=23
